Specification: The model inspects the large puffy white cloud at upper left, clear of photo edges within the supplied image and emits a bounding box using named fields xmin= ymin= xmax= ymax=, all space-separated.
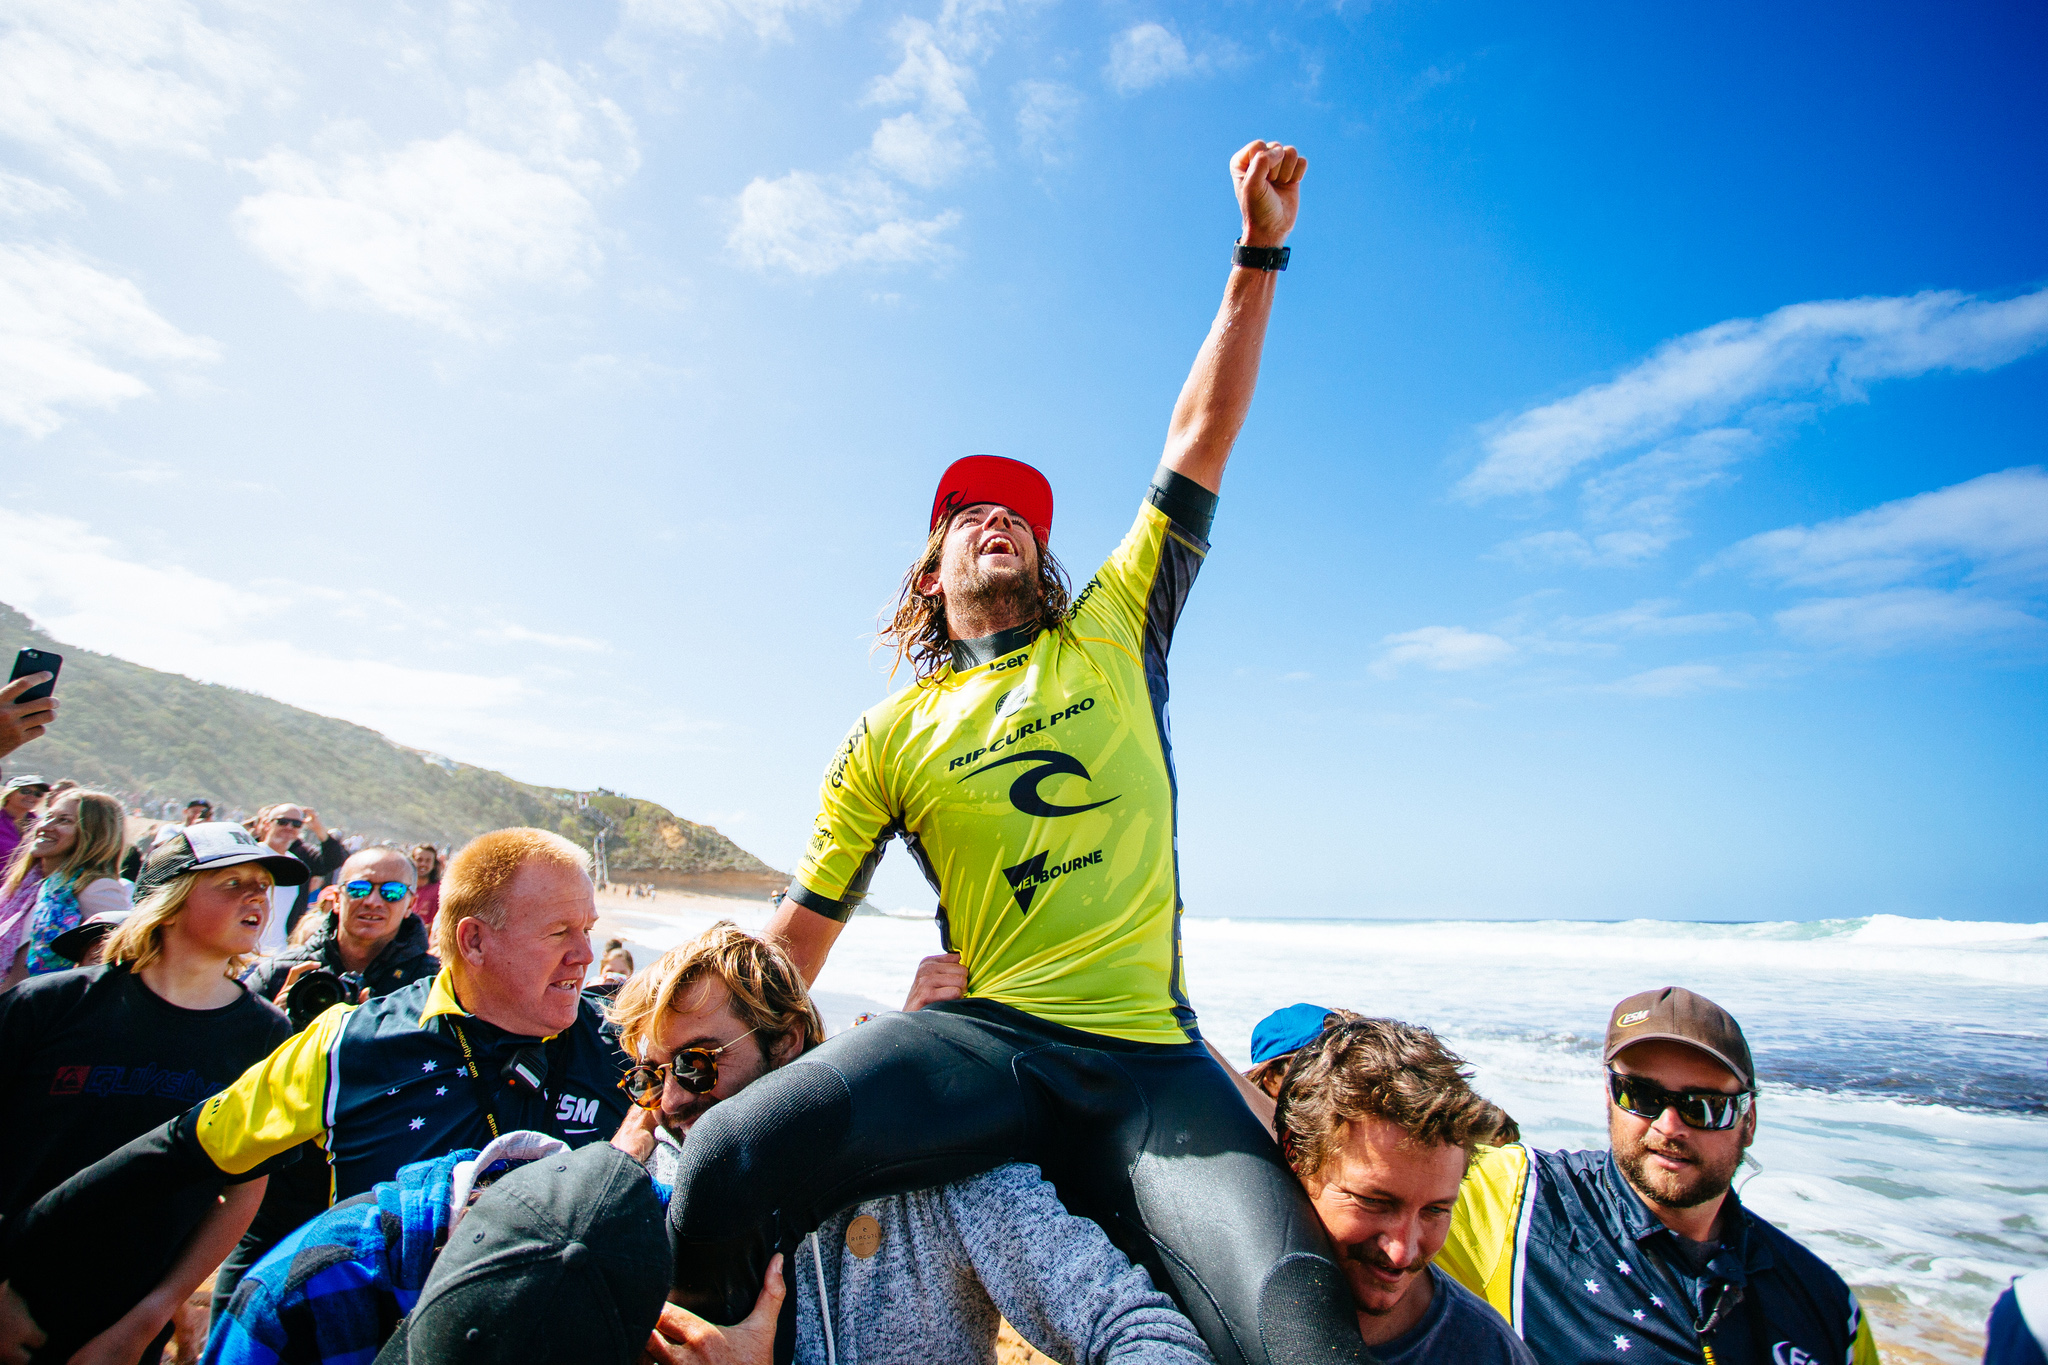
xmin=236 ymin=61 xmax=639 ymax=336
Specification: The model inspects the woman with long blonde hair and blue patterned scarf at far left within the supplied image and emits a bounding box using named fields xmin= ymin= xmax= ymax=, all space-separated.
xmin=0 ymin=788 xmax=129 ymax=990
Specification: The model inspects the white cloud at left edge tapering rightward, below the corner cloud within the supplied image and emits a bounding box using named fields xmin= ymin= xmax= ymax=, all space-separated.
xmin=0 ymin=244 xmax=219 ymax=436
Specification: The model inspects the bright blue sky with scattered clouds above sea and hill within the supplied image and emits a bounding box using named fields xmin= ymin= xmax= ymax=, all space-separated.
xmin=0 ymin=0 xmax=2048 ymax=919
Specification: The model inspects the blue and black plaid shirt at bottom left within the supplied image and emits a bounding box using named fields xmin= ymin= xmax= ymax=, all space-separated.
xmin=203 ymin=1148 xmax=477 ymax=1365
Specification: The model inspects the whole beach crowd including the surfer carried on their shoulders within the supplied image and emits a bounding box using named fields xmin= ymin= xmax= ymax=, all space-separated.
xmin=0 ymin=141 xmax=2048 ymax=1365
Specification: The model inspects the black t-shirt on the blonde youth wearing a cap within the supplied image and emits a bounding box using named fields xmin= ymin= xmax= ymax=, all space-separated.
xmin=0 ymin=966 xmax=291 ymax=1218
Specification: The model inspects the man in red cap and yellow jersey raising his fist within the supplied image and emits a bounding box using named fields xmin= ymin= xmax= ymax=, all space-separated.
xmin=670 ymin=141 xmax=1370 ymax=1365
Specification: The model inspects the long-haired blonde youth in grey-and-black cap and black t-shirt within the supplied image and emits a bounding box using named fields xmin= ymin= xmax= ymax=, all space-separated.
xmin=0 ymin=823 xmax=305 ymax=1365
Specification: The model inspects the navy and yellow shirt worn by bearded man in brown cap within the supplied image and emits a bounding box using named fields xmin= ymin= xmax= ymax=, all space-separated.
xmin=1436 ymin=1144 xmax=1878 ymax=1365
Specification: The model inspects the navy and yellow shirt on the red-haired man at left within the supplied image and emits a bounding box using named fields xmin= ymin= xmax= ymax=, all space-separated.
xmin=193 ymin=970 xmax=631 ymax=1199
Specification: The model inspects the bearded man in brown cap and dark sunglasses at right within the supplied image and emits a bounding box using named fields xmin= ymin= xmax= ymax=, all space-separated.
xmin=1438 ymin=986 xmax=1878 ymax=1365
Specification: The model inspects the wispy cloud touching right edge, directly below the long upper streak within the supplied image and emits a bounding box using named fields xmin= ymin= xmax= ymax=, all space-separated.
xmin=1720 ymin=467 xmax=2048 ymax=589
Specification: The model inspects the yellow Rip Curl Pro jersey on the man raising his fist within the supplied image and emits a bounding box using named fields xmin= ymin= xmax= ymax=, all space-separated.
xmin=791 ymin=469 xmax=1217 ymax=1044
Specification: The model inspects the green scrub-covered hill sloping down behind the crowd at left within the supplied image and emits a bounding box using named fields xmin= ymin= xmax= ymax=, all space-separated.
xmin=0 ymin=604 xmax=776 ymax=880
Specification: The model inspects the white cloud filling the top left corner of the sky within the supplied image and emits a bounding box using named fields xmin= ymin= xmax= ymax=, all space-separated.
xmin=0 ymin=0 xmax=283 ymax=190
